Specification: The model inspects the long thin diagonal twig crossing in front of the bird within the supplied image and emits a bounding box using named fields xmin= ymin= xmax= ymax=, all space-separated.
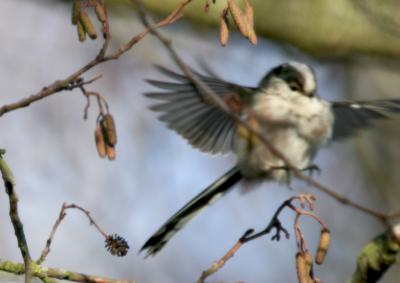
xmin=132 ymin=0 xmax=400 ymax=224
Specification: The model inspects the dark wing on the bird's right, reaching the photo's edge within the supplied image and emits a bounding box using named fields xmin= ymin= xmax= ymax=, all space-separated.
xmin=332 ymin=99 xmax=400 ymax=140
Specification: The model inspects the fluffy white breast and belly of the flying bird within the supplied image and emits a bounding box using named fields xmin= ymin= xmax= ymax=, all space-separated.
xmin=234 ymin=89 xmax=333 ymax=180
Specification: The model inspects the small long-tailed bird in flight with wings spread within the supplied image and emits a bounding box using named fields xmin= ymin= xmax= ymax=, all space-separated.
xmin=141 ymin=62 xmax=400 ymax=255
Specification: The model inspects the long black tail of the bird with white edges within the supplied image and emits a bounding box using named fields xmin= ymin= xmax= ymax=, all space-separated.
xmin=140 ymin=166 xmax=242 ymax=256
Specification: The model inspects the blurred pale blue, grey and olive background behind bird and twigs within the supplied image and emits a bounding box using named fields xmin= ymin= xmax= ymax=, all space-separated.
xmin=0 ymin=0 xmax=400 ymax=283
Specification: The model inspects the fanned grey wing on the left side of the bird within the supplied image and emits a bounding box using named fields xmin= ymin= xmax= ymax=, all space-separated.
xmin=145 ymin=67 xmax=250 ymax=154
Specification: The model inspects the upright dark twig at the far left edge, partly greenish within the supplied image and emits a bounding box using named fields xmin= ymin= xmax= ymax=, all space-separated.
xmin=0 ymin=150 xmax=32 ymax=283
